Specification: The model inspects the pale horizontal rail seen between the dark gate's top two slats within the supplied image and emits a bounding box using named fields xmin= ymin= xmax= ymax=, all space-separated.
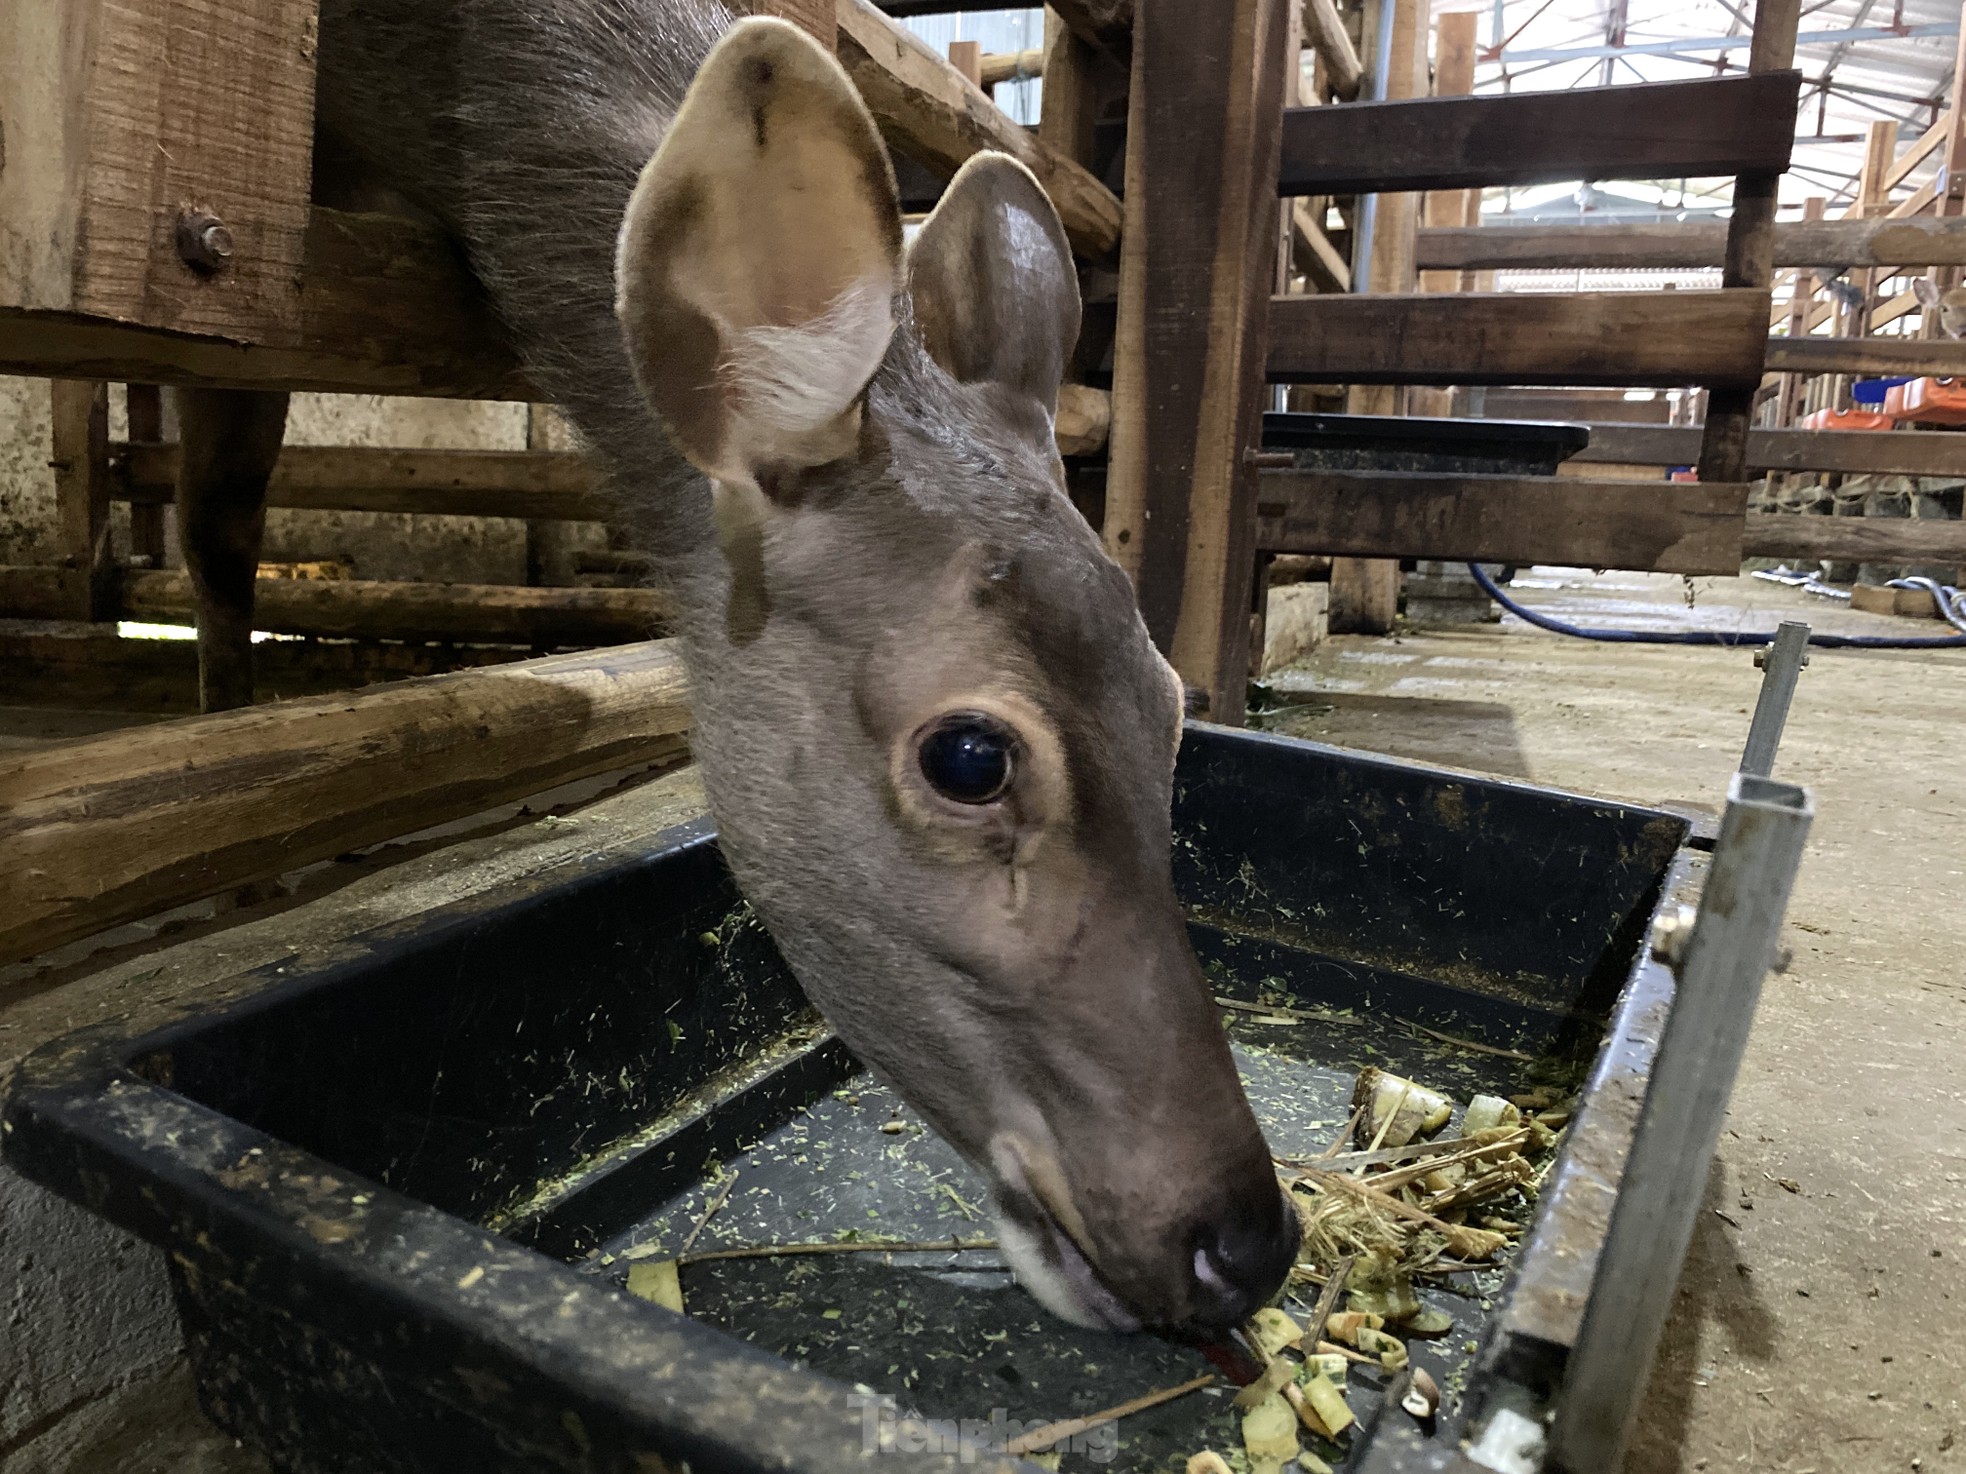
xmin=1419 ymin=218 xmax=1966 ymax=271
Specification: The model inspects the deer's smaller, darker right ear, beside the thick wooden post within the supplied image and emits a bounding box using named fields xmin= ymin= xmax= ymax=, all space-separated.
xmin=908 ymin=153 xmax=1079 ymax=417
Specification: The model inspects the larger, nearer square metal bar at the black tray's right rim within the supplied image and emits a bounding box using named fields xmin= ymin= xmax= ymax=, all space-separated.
xmin=1551 ymin=772 xmax=1813 ymax=1474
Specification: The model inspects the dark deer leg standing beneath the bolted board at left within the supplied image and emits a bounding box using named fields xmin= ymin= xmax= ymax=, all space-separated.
xmin=177 ymin=389 xmax=287 ymax=711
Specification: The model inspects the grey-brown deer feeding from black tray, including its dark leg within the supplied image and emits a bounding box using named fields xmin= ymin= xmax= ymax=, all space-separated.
xmin=179 ymin=0 xmax=1300 ymax=1340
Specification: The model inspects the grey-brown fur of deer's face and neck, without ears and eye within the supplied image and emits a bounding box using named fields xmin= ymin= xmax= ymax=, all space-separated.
xmin=320 ymin=0 xmax=1296 ymax=1325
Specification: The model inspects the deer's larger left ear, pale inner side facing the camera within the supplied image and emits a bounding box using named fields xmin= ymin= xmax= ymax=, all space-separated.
xmin=615 ymin=18 xmax=900 ymax=482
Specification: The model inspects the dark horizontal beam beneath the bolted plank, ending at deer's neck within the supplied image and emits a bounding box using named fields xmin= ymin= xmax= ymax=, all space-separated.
xmin=0 ymin=208 xmax=539 ymax=399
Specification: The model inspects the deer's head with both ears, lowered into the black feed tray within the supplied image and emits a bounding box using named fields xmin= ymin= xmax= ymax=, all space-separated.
xmin=617 ymin=20 xmax=1298 ymax=1329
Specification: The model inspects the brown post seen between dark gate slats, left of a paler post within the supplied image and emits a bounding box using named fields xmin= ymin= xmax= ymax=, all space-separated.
xmin=1331 ymin=0 xmax=1427 ymax=635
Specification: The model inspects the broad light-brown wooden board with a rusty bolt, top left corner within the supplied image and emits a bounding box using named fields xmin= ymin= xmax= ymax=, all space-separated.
xmin=0 ymin=0 xmax=315 ymax=346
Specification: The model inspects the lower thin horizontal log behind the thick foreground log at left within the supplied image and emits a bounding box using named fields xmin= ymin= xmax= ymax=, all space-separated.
xmin=0 ymin=566 xmax=670 ymax=647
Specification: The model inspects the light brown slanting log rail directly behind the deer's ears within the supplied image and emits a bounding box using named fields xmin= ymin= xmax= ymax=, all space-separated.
xmin=838 ymin=0 xmax=1121 ymax=257
